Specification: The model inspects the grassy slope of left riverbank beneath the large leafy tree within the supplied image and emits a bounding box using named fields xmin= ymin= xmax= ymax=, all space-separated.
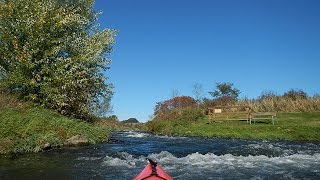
xmin=0 ymin=94 xmax=110 ymax=154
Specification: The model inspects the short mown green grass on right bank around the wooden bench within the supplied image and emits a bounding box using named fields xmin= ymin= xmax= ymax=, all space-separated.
xmin=147 ymin=112 xmax=320 ymax=141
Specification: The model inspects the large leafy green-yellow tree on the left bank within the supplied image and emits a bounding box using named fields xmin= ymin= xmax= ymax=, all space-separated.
xmin=0 ymin=0 xmax=115 ymax=121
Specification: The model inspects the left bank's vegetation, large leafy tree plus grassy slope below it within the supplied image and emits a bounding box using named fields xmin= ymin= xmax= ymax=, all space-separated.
xmin=0 ymin=0 xmax=115 ymax=153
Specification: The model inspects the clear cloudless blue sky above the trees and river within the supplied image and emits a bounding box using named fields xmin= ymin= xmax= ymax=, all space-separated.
xmin=95 ymin=0 xmax=320 ymax=122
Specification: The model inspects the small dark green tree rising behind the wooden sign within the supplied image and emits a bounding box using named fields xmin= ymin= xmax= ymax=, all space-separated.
xmin=209 ymin=82 xmax=240 ymax=105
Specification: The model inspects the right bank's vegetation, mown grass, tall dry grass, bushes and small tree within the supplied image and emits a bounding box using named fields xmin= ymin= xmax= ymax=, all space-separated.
xmin=147 ymin=83 xmax=320 ymax=141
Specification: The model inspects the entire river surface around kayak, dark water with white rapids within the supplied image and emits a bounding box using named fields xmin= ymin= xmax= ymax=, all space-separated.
xmin=0 ymin=131 xmax=320 ymax=180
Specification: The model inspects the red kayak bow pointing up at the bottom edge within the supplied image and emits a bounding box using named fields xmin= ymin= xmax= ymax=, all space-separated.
xmin=133 ymin=159 xmax=172 ymax=180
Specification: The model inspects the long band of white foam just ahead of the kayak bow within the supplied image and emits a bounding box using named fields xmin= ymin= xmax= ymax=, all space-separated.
xmin=103 ymin=151 xmax=320 ymax=173
